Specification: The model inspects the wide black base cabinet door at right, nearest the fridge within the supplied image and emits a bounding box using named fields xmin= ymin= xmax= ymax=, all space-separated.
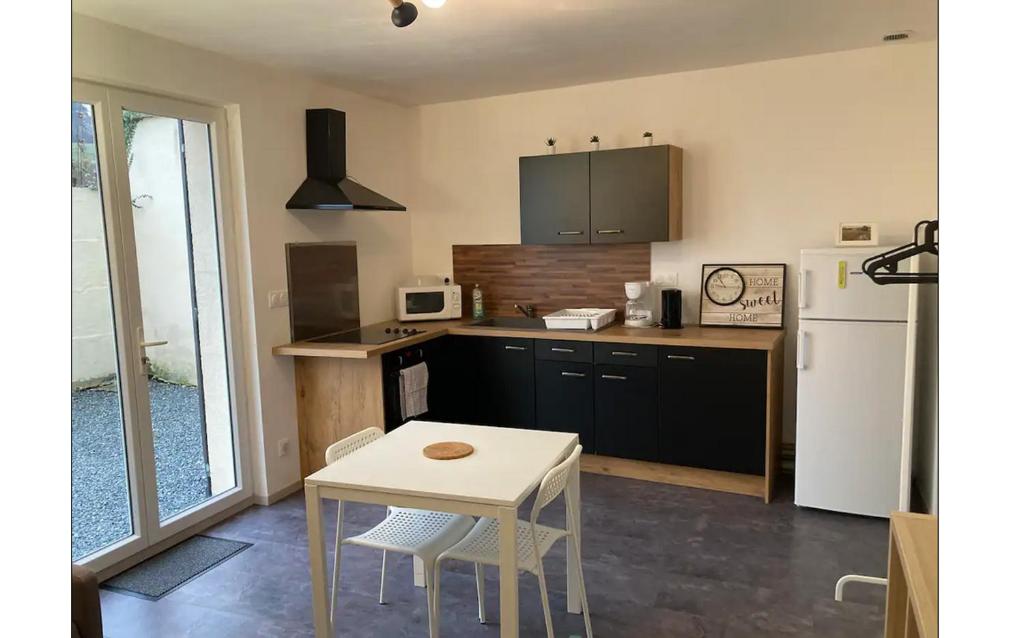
xmin=657 ymin=347 xmax=767 ymax=474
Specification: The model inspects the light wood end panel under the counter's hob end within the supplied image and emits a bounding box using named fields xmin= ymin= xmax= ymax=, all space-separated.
xmin=295 ymin=356 xmax=384 ymax=476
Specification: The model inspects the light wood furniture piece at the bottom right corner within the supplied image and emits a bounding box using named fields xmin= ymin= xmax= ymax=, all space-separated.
xmin=890 ymin=512 xmax=939 ymax=638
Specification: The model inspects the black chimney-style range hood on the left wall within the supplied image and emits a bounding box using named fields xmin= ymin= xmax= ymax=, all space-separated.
xmin=286 ymin=109 xmax=406 ymax=211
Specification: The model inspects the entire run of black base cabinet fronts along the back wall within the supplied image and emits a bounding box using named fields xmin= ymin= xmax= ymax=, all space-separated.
xmin=423 ymin=335 xmax=768 ymax=474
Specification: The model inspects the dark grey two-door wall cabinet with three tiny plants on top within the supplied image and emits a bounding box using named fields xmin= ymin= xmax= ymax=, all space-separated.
xmin=519 ymin=144 xmax=683 ymax=244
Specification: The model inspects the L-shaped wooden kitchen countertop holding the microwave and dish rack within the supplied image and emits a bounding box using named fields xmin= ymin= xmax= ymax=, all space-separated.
xmin=273 ymin=318 xmax=785 ymax=358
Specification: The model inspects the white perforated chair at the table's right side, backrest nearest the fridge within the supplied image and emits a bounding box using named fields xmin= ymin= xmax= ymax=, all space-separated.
xmin=433 ymin=445 xmax=594 ymax=638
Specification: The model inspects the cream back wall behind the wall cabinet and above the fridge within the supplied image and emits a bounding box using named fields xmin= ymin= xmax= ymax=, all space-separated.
xmin=412 ymin=42 xmax=937 ymax=441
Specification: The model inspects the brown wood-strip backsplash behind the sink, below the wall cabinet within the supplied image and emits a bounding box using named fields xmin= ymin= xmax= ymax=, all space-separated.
xmin=452 ymin=244 xmax=650 ymax=320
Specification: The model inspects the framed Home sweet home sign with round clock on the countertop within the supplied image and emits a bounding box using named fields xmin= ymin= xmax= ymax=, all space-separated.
xmin=700 ymin=263 xmax=785 ymax=329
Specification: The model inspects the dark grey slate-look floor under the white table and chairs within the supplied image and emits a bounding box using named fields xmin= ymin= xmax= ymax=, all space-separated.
xmin=102 ymin=474 xmax=888 ymax=638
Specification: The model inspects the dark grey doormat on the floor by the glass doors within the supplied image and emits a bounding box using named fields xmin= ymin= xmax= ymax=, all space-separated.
xmin=101 ymin=536 xmax=252 ymax=600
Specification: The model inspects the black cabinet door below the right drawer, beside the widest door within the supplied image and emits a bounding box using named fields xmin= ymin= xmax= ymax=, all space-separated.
xmin=594 ymin=365 xmax=657 ymax=461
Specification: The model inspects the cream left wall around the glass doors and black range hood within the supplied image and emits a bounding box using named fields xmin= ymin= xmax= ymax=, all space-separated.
xmin=72 ymin=15 xmax=415 ymax=495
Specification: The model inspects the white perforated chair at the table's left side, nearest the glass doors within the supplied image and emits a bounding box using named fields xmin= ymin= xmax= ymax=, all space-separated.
xmin=325 ymin=427 xmax=473 ymax=636
